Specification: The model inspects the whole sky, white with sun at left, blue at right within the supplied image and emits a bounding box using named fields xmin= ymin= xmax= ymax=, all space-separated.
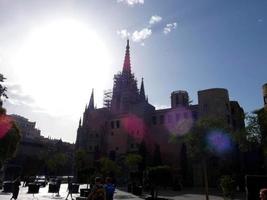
xmin=0 ymin=0 xmax=267 ymax=142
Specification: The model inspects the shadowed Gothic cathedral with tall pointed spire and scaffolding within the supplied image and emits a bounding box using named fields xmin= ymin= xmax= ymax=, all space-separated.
xmin=76 ymin=40 xmax=244 ymax=167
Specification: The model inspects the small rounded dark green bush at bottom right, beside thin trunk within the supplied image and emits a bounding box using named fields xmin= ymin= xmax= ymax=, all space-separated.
xmin=220 ymin=175 xmax=235 ymax=199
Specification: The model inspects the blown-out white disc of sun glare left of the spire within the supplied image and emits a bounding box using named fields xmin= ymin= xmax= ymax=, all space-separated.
xmin=13 ymin=19 xmax=111 ymax=118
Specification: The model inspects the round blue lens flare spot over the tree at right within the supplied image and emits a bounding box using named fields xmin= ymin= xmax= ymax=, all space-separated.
xmin=207 ymin=131 xmax=232 ymax=154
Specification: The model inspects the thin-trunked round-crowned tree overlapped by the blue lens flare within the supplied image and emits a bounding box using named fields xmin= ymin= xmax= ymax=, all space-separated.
xmin=185 ymin=118 xmax=228 ymax=200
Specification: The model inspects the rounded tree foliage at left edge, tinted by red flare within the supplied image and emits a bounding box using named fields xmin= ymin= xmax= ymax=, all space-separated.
xmin=0 ymin=120 xmax=21 ymax=167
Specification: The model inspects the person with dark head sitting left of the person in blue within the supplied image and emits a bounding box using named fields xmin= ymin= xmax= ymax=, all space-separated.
xmin=87 ymin=177 xmax=106 ymax=200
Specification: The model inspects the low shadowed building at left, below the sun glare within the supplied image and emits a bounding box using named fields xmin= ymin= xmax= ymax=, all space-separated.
xmin=5 ymin=115 xmax=74 ymax=177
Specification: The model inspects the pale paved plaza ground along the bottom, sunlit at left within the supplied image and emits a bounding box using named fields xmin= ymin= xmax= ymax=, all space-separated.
xmin=0 ymin=184 xmax=245 ymax=200
